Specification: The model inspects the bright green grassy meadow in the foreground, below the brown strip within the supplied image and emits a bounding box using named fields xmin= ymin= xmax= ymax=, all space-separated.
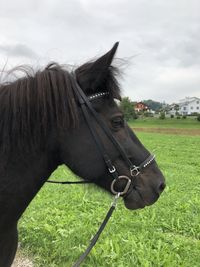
xmin=19 ymin=133 xmax=200 ymax=267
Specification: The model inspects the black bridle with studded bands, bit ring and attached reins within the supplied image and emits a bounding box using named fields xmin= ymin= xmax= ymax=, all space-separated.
xmin=47 ymin=72 xmax=155 ymax=267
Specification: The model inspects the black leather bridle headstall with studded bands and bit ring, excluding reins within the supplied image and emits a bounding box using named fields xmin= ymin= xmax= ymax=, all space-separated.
xmin=72 ymin=73 xmax=155 ymax=196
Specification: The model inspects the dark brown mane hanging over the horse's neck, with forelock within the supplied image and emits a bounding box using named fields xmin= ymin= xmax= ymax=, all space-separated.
xmin=0 ymin=63 xmax=119 ymax=153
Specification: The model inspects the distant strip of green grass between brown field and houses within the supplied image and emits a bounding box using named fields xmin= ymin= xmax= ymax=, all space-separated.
xmin=129 ymin=117 xmax=200 ymax=129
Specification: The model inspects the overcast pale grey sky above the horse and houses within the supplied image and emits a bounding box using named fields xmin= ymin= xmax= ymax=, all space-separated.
xmin=0 ymin=0 xmax=200 ymax=103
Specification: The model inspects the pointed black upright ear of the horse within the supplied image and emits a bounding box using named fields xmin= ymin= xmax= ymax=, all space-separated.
xmin=76 ymin=42 xmax=119 ymax=91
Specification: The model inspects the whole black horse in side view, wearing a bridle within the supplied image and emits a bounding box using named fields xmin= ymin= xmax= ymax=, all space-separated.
xmin=0 ymin=43 xmax=165 ymax=267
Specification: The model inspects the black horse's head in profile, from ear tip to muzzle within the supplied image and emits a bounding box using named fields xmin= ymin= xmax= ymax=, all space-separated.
xmin=60 ymin=44 xmax=165 ymax=209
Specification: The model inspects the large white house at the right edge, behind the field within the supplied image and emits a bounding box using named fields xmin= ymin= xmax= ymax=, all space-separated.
xmin=178 ymin=97 xmax=200 ymax=115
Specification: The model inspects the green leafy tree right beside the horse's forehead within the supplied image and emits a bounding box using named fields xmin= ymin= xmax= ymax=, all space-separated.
xmin=120 ymin=97 xmax=137 ymax=121
